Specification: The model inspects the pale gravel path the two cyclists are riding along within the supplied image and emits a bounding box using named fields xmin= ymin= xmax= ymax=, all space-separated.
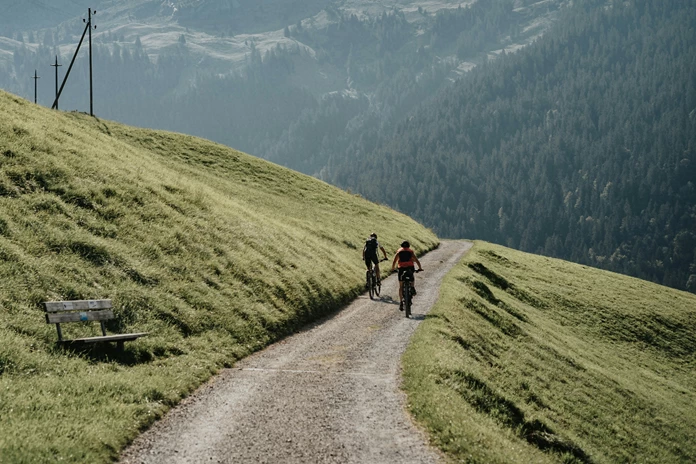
xmin=121 ymin=241 xmax=471 ymax=464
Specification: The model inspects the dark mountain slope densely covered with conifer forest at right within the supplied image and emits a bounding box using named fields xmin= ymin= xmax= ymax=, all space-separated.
xmin=328 ymin=0 xmax=696 ymax=292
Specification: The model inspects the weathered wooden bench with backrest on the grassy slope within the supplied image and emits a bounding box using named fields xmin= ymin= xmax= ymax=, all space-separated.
xmin=44 ymin=300 xmax=148 ymax=350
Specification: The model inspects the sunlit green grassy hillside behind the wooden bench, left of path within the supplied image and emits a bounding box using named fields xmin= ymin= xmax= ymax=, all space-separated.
xmin=0 ymin=92 xmax=437 ymax=463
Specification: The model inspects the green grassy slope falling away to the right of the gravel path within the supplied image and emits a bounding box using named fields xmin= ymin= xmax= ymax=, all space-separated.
xmin=403 ymin=242 xmax=696 ymax=463
